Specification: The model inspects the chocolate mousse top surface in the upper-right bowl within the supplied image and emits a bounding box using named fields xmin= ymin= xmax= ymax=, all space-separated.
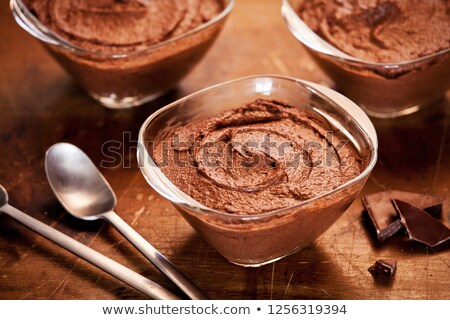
xmin=298 ymin=0 xmax=450 ymax=62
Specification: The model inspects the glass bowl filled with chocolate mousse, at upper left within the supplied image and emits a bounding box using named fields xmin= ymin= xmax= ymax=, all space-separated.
xmin=10 ymin=0 xmax=234 ymax=108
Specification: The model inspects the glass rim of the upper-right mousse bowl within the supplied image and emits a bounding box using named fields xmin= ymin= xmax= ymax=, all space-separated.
xmin=281 ymin=0 xmax=450 ymax=69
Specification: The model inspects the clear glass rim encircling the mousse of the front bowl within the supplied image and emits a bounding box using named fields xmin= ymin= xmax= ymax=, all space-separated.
xmin=137 ymin=74 xmax=378 ymax=221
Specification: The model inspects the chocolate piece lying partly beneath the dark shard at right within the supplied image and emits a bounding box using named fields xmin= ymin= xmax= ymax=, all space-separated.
xmin=362 ymin=190 xmax=443 ymax=242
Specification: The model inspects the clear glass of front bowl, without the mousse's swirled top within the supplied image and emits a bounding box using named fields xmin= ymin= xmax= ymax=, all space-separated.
xmin=138 ymin=76 xmax=378 ymax=266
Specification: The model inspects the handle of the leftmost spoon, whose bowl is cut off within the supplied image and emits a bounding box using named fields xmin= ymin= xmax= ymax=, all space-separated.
xmin=0 ymin=204 xmax=179 ymax=300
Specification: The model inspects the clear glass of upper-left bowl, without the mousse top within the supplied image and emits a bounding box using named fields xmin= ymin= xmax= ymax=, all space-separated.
xmin=10 ymin=0 xmax=234 ymax=108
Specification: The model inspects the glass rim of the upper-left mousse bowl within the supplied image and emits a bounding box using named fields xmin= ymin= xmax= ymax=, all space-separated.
xmin=9 ymin=0 xmax=235 ymax=59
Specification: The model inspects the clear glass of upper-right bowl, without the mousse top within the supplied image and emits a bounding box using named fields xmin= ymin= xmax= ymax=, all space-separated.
xmin=281 ymin=0 xmax=450 ymax=118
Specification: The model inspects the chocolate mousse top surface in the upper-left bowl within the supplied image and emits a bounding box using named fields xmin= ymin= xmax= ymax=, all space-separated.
xmin=25 ymin=0 xmax=224 ymax=52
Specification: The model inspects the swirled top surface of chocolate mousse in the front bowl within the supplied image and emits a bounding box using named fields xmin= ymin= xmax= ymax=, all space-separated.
xmin=153 ymin=99 xmax=362 ymax=214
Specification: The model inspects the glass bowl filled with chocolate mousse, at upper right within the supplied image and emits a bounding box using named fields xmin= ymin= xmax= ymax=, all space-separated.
xmin=281 ymin=0 xmax=450 ymax=118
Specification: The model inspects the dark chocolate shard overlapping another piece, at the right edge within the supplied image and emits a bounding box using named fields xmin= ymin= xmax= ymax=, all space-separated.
xmin=392 ymin=199 xmax=450 ymax=247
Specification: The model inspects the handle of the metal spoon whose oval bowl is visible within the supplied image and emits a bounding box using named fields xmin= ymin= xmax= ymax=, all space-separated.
xmin=103 ymin=211 xmax=208 ymax=300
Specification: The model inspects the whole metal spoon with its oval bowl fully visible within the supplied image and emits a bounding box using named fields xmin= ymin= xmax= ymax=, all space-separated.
xmin=45 ymin=143 xmax=207 ymax=299
